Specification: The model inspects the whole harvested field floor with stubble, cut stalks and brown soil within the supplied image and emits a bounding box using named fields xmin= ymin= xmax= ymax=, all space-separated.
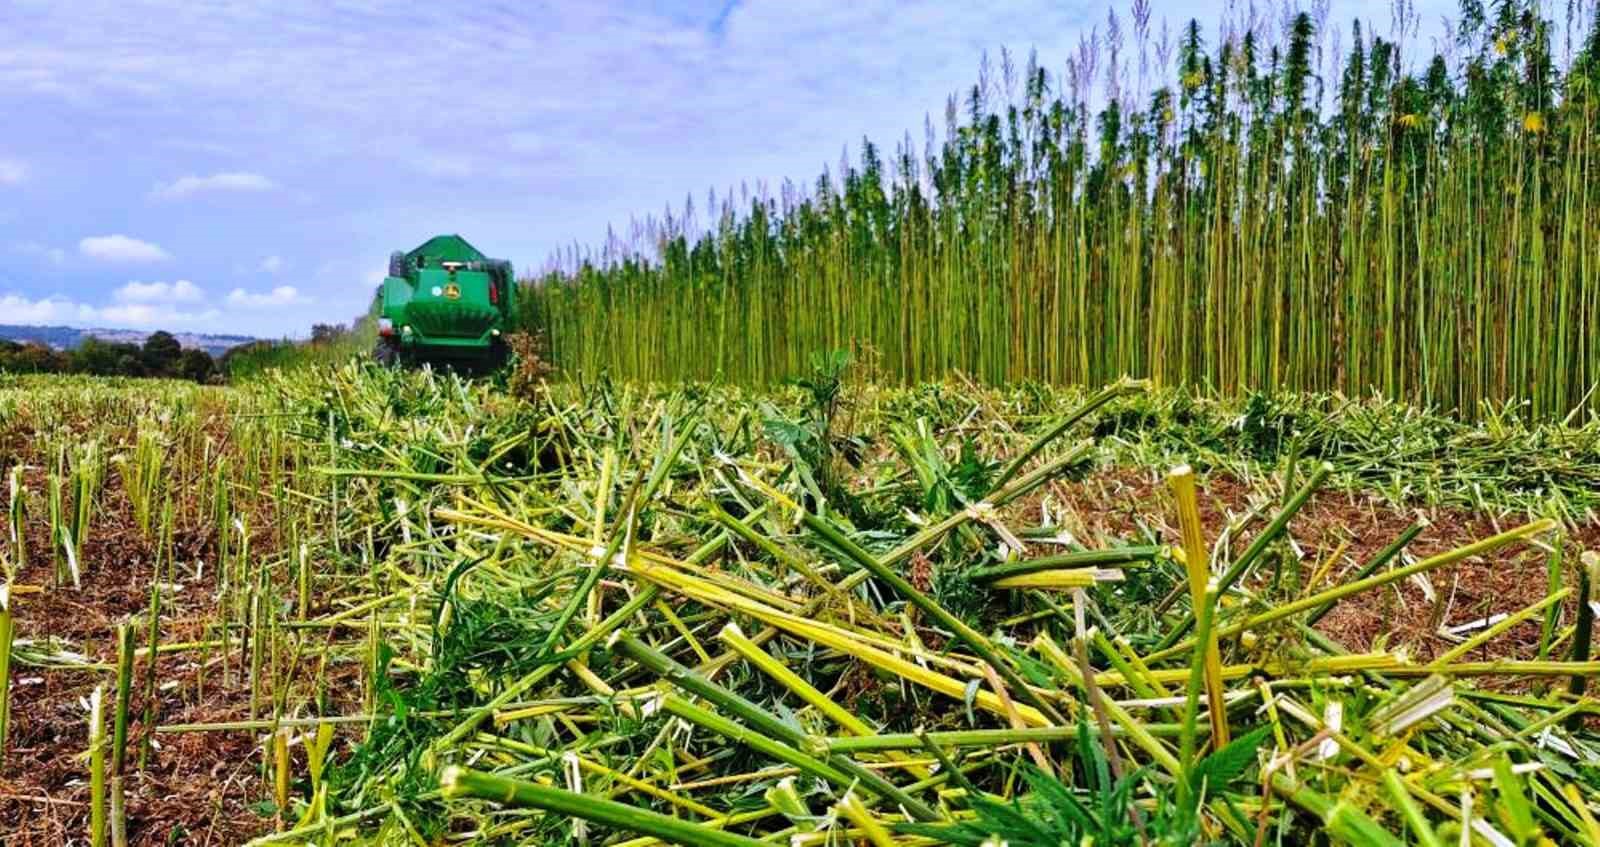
xmin=0 ymin=360 xmax=1600 ymax=845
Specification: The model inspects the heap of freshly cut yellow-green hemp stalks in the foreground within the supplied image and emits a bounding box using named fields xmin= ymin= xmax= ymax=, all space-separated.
xmin=243 ymin=369 xmax=1600 ymax=845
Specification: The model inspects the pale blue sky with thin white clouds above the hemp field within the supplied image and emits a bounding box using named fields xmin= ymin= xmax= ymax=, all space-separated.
xmin=0 ymin=0 xmax=1454 ymax=336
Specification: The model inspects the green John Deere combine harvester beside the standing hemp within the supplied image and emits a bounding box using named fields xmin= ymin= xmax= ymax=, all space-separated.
xmin=374 ymin=235 xmax=517 ymax=370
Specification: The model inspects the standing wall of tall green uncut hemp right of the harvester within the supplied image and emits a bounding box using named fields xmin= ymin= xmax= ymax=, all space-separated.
xmin=520 ymin=0 xmax=1600 ymax=419
